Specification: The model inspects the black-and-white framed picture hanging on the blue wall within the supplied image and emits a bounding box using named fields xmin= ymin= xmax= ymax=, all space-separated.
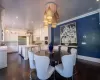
xmin=60 ymin=22 xmax=77 ymax=44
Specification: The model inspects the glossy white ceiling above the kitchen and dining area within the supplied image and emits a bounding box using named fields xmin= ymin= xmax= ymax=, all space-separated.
xmin=2 ymin=0 xmax=99 ymax=29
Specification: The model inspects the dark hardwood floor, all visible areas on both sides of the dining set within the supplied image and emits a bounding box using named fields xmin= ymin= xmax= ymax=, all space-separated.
xmin=0 ymin=53 xmax=100 ymax=80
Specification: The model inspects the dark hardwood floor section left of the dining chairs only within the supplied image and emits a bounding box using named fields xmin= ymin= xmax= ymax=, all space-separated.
xmin=0 ymin=53 xmax=30 ymax=80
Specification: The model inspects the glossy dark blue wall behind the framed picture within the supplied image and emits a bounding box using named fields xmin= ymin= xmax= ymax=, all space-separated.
xmin=52 ymin=13 xmax=100 ymax=58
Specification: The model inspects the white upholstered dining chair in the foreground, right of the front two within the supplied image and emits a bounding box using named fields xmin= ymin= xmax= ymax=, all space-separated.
xmin=55 ymin=55 xmax=73 ymax=78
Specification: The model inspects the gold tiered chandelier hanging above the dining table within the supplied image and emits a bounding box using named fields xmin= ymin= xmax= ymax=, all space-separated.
xmin=44 ymin=2 xmax=59 ymax=28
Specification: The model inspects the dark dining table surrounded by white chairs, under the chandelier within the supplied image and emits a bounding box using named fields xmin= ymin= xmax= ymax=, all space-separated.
xmin=35 ymin=50 xmax=68 ymax=67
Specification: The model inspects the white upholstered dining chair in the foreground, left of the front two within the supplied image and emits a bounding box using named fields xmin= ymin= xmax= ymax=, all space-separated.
xmin=34 ymin=55 xmax=54 ymax=80
